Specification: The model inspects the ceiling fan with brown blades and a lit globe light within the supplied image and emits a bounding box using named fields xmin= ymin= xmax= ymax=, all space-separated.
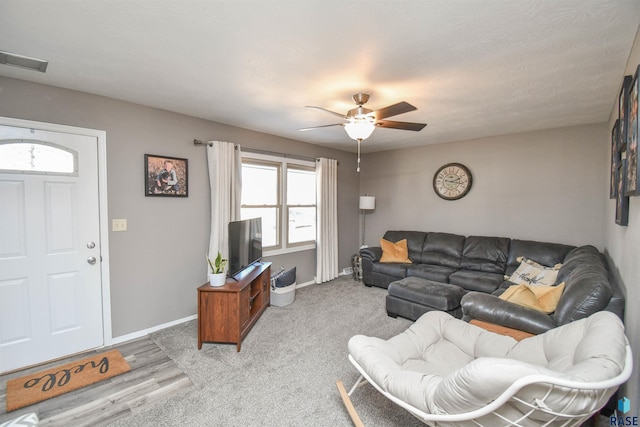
xmin=298 ymin=93 xmax=426 ymax=172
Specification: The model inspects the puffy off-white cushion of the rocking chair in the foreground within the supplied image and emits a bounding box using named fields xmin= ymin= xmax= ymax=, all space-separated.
xmin=349 ymin=311 xmax=626 ymax=414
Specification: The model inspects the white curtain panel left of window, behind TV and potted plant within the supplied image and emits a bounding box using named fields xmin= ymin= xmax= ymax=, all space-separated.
xmin=207 ymin=141 xmax=242 ymax=268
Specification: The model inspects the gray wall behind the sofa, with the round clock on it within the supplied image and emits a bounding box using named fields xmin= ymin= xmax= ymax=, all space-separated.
xmin=361 ymin=124 xmax=608 ymax=250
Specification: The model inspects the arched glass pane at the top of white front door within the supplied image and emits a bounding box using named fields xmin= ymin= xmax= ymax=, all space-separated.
xmin=0 ymin=141 xmax=78 ymax=174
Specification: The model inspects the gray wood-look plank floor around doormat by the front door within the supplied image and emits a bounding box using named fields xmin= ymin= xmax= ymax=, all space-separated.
xmin=0 ymin=337 xmax=193 ymax=427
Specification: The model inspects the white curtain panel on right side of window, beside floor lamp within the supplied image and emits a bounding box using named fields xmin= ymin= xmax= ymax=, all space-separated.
xmin=316 ymin=158 xmax=338 ymax=283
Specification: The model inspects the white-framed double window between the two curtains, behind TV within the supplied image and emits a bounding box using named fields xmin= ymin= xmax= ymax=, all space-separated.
xmin=240 ymin=153 xmax=316 ymax=253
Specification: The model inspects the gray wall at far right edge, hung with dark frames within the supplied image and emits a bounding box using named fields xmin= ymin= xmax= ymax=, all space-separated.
xmin=602 ymin=25 xmax=640 ymax=415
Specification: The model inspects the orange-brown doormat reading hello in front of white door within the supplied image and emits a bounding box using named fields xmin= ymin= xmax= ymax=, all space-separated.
xmin=7 ymin=350 xmax=131 ymax=412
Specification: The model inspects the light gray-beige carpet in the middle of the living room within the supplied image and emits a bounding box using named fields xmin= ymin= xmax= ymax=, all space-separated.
xmin=106 ymin=276 xmax=424 ymax=427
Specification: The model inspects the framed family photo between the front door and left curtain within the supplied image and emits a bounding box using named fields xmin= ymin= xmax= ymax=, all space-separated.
xmin=144 ymin=154 xmax=189 ymax=197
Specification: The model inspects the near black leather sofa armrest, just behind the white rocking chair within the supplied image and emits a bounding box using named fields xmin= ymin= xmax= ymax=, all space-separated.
xmin=461 ymin=292 xmax=557 ymax=334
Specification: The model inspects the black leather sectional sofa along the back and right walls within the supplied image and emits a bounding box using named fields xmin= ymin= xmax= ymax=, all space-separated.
xmin=360 ymin=231 xmax=625 ymax=334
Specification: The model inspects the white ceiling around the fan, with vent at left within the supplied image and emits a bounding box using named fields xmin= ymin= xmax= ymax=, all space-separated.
xmin=0 ymin=0 xmax=640 ymax=152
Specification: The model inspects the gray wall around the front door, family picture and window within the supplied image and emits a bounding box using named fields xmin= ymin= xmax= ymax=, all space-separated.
xmin=0 ymin=77 xmax=358 ymax=337
